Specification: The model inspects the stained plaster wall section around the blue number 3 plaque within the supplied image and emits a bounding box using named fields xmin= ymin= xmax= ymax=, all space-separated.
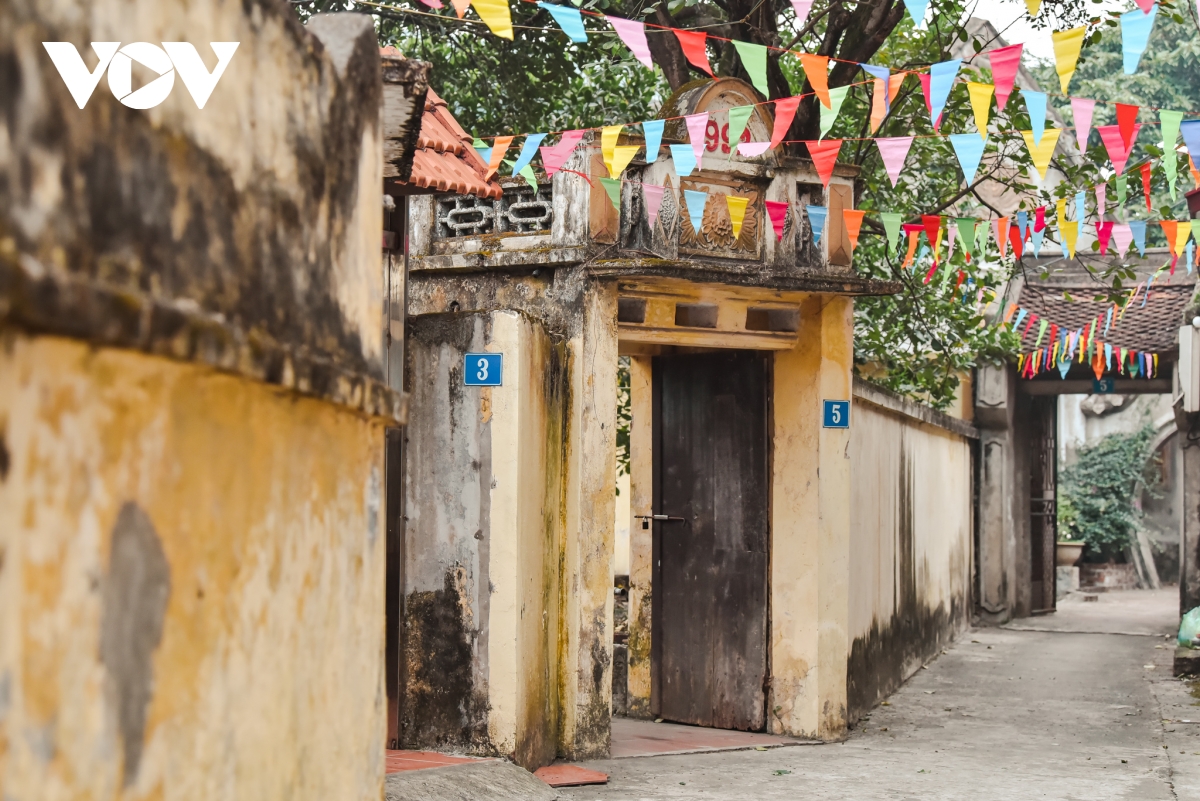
xmin=401 ymin=311 xmax=569 ymax=767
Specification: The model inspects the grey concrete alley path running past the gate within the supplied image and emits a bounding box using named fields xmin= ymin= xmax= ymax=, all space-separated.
xmin=560 ymin=591 xmax=1200 ymax=801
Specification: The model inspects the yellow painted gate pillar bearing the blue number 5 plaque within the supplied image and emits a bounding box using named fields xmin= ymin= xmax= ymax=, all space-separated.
xmin=768 ymin=296 xmax=853 ymax=739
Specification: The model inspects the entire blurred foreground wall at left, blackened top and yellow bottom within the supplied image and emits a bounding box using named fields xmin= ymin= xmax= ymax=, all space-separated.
xmin=0 ymin=0 xmax=388 ymax=799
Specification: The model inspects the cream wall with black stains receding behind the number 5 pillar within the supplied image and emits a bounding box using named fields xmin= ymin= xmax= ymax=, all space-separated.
xmin=847 ymin=398 xmax=972 ymax=721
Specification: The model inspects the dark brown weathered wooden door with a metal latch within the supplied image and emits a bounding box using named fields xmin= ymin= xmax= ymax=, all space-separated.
xmin=652 ymin=350 xmax=770 ymax=731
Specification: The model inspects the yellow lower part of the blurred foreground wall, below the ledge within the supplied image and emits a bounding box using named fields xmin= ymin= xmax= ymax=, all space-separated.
xmin=0 ymin=331 xmax=384 ymax=801
